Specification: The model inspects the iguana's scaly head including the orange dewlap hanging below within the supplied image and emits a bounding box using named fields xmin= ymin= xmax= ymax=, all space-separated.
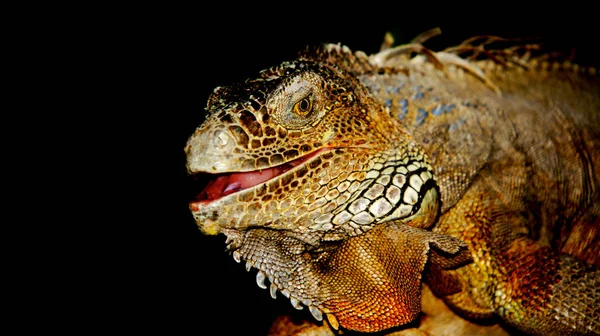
xmin=185 ymin=45 xmax=472 ymax=331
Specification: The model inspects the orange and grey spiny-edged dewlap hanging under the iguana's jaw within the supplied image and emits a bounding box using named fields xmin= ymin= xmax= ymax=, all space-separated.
xmin=232 ymin=222 xmax=470 ymax=332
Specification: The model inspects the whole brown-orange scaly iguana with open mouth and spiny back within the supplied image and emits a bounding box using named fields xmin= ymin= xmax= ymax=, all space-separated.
xmin=185 ymin=33 xmax=600 ymax=335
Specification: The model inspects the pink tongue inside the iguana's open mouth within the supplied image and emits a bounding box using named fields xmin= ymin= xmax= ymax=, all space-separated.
xmin=204 ymin=167 xmax=283 ymax=200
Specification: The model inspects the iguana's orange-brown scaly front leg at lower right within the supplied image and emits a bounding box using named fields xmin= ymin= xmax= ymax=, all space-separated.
xmin=435 ymin=180 xmax=600 ymax=335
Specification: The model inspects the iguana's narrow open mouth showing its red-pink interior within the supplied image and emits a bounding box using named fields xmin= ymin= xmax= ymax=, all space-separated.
xmin=192 ymin=149 xmax=323 ymax=203
